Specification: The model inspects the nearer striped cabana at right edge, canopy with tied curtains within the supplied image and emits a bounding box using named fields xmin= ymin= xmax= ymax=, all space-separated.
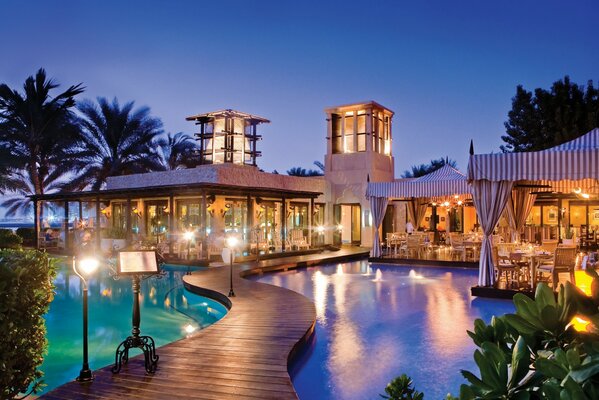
xmin=468 ymin=129 xmax=599 ymax=286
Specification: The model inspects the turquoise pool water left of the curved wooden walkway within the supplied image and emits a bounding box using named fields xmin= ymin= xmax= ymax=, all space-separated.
xmin=41 ymin=265 xmax=227 ymax=393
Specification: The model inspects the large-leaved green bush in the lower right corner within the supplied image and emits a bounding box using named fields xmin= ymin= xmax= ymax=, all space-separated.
xmin=393 ymin=271 xmax=599 ymax=400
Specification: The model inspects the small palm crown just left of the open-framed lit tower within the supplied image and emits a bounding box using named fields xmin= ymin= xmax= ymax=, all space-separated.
xmin=158 ymin=132 xmax=199 ymax=170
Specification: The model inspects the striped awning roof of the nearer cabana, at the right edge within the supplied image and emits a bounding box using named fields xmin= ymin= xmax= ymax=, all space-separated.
xmin=468 ymin=129 xmax=599 ymax=182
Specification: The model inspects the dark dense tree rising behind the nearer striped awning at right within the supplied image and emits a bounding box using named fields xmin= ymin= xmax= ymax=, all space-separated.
xmin=500 ymin=76 xmax=599 ymax=152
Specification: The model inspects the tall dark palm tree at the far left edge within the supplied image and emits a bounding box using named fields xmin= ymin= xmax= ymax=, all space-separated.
xmin=0 ymin=69 xmax=84 ymax=215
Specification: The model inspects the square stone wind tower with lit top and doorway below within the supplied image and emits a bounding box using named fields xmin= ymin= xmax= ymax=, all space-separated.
xmin=325 ymin=101 xmax=394 ymax=246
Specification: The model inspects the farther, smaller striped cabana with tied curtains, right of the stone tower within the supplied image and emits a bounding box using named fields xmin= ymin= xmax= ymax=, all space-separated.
xmin=366 ymin=164 xmax=470 ymax=257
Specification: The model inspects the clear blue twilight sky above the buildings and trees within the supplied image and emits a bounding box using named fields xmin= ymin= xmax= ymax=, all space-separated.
xmin=0 ymin=0 xmax=599 ymax=176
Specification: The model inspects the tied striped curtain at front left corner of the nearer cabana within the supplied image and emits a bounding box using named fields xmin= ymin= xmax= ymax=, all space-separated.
xmin=472 ymin=180 xmax=514 ymax=286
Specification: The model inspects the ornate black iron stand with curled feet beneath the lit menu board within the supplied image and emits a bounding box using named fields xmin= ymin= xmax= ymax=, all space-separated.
xmin=112 ymin=275 xmax=158 ymax=374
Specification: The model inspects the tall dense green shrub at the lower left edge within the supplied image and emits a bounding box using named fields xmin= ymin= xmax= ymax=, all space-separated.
xmin=0 ymin=250 xmax=56 ymax=399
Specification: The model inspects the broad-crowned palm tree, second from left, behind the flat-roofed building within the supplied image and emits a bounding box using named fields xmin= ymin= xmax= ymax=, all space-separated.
xmin=63 ymin=97 xmax=164 ymax=190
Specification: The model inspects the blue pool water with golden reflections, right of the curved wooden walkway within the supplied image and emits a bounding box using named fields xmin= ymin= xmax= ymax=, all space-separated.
xmin=254 ymin=261 xmax=514 ymax=400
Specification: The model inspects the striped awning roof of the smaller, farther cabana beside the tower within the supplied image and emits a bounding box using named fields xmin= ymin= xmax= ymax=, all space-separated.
xmin=366 ymin=165 xmax=470 ymax=199
